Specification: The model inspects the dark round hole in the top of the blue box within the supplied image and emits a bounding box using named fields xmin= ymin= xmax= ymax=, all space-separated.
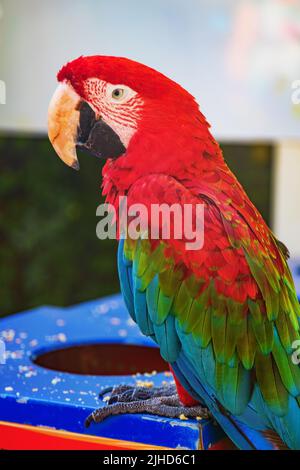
xmin=33 ymin=343 xmax=169 ymax=375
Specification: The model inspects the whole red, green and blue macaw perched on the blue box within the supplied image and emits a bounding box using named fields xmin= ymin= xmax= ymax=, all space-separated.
xmin=49 ymin=56 xmax=300 ymax=449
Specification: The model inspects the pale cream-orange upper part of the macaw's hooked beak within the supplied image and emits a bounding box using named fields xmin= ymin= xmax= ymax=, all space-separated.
xmin=48 ymin=83 xmax=81 ymax=170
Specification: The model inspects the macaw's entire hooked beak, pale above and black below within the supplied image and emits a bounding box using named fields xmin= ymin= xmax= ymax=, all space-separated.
xmin=48 ymin=83 xmax=126 ymax=170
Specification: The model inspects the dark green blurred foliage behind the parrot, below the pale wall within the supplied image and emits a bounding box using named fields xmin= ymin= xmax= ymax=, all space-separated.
xmin=0 ymin=136 xmax=271 ymax=316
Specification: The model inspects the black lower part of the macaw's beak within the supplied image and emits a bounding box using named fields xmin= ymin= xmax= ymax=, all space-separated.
xmin=77 ymin=101 xmax=126 ymax=158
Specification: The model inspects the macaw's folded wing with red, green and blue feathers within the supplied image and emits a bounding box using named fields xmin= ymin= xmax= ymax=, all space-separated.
xmin=124 ymin=172 xmax=300 ymax=416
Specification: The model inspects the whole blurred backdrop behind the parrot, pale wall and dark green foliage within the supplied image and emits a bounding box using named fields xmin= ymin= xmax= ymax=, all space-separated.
xmin=0 ymin=0 xmax=300 ymax=315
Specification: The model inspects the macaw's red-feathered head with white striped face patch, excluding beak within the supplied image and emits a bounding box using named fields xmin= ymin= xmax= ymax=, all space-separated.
xmin=53 ymin=56 xmax=221 ymax=193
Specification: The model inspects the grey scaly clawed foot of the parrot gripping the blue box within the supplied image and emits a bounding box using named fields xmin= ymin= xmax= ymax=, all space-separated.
xmin=85 ymin=384 xmax=210 ymax=427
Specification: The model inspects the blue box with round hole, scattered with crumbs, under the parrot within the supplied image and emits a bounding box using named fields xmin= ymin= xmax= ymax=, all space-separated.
xmin=0 ymin=295 xmax=225 ymax=449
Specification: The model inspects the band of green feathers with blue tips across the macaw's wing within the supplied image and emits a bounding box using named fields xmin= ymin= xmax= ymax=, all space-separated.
xmin=124 ymin=217 xmax=300 ymax=416
